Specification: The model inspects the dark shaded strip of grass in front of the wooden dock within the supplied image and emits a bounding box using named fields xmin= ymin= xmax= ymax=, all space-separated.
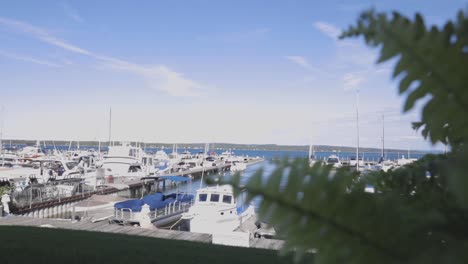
xmin=0 ymin=226 xmax=310 ymax=264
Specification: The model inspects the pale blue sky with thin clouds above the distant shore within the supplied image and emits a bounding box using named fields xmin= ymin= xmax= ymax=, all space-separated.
xmin=0 ymin=0 xmax=466 ymax=149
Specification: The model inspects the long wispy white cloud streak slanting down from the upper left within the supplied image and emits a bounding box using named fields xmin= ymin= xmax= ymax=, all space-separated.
xmin=0 ymin=17 xmax=202 ymax=96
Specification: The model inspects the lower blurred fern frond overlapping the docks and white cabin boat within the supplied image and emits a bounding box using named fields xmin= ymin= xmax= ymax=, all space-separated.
xmin=225 ymin=158 xmax=468 ymax=263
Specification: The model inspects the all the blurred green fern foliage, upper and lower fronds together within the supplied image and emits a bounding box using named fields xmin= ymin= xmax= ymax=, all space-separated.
xmin=221 ymin=7 xmax=468 ymax=263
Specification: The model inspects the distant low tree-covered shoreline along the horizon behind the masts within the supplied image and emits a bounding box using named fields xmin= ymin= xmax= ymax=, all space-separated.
xmin=3 ymin=139 xmax=441 ymax=154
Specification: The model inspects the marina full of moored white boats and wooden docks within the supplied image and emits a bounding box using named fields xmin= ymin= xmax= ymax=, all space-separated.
xmin=0 ymin=140 xmax=424 ymax=250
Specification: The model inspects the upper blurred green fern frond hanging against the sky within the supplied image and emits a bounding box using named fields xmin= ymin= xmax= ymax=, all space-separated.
xmin=341 ymin=10 xmax=468 ymax=145
